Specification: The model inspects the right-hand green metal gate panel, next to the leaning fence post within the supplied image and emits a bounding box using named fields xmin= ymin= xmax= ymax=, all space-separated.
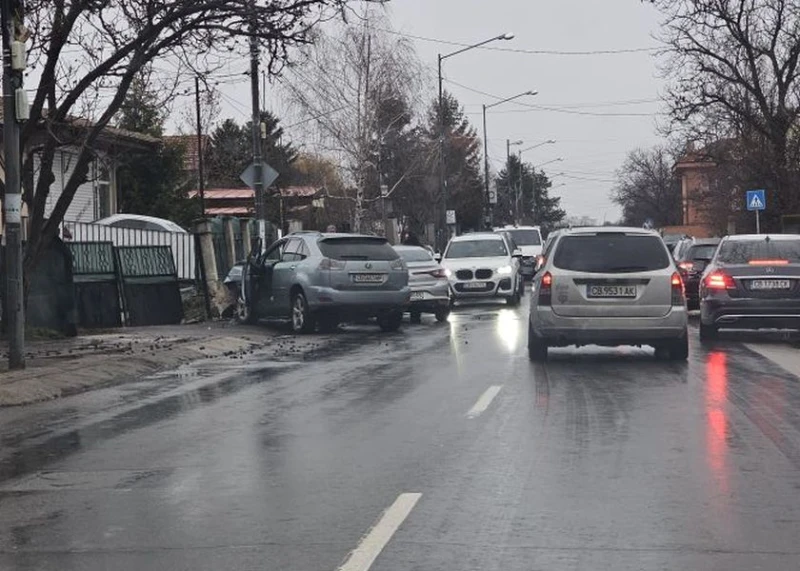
xmin=117 ymin=246 xmax=183 ymax=326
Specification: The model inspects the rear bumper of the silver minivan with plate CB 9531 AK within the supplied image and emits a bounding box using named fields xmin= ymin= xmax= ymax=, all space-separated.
xmin=531 ymin=307 xmax=688 ymax=346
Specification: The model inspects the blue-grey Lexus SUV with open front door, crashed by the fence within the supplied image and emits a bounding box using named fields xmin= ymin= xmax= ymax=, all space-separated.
xmin=237 ymin=232 xmax=411 ymax=333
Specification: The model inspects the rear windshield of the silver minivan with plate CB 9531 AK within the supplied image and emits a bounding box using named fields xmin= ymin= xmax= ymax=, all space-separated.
xmin=553 ymin=234 xmax=670 ymax=274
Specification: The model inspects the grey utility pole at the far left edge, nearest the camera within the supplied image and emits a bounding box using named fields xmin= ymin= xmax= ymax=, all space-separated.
xmin=0 ymin=0 xmax=27 ymax=369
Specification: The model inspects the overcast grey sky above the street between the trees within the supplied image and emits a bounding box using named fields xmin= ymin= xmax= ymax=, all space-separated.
xmin=208 ymin=0 xmax=663 ymax=221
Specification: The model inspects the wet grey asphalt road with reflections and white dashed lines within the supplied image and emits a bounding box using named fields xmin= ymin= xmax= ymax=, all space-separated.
xmin=0 ymin=298 xmax=800 ymax=571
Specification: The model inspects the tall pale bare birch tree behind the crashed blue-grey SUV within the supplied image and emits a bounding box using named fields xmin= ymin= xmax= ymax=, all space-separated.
xmin=281 ymin=8 xmax=428 ymax=231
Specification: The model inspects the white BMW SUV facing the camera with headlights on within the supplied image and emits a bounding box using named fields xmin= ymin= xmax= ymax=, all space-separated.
xmin=442 ymin=232 xmax=525 ymax=305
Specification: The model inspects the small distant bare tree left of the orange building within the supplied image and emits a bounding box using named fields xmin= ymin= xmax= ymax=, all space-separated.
xmin=611 ymin=147 xmax=681 ymax=227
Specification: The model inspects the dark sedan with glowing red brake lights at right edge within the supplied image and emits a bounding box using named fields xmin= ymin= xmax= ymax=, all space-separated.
xmin=700 ymin=234 xmax=800 ymax=340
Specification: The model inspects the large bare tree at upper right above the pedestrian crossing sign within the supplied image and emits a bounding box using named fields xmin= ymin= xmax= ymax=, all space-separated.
xmin=653 ymin=0 xmax=800 ymax=228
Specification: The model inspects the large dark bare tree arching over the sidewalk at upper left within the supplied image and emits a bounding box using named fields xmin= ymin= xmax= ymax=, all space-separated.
xmin=11 ymin=0 xmax=376 ymax=286
